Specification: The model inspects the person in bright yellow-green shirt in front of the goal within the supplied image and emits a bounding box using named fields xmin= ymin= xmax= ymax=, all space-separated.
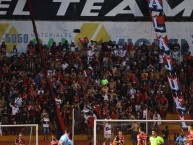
xmin=149 ymin=131 xmax=164 ymax=145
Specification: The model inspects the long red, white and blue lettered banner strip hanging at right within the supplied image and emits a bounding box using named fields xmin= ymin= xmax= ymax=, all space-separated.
xmin=147 ymin=0 xmax=191 ymax=129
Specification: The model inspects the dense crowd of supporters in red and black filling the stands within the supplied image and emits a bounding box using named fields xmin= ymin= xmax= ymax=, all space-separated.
xmin=0 ymin=41 xmax=193 ymax=137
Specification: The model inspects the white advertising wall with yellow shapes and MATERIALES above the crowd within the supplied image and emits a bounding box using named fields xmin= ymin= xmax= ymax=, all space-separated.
xmin=0 ymin=21 xmax=193 ymax=53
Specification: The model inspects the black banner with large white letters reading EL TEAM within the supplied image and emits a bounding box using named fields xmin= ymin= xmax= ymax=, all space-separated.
xmin=0 ymin=0 xmax=193 ymax=21
